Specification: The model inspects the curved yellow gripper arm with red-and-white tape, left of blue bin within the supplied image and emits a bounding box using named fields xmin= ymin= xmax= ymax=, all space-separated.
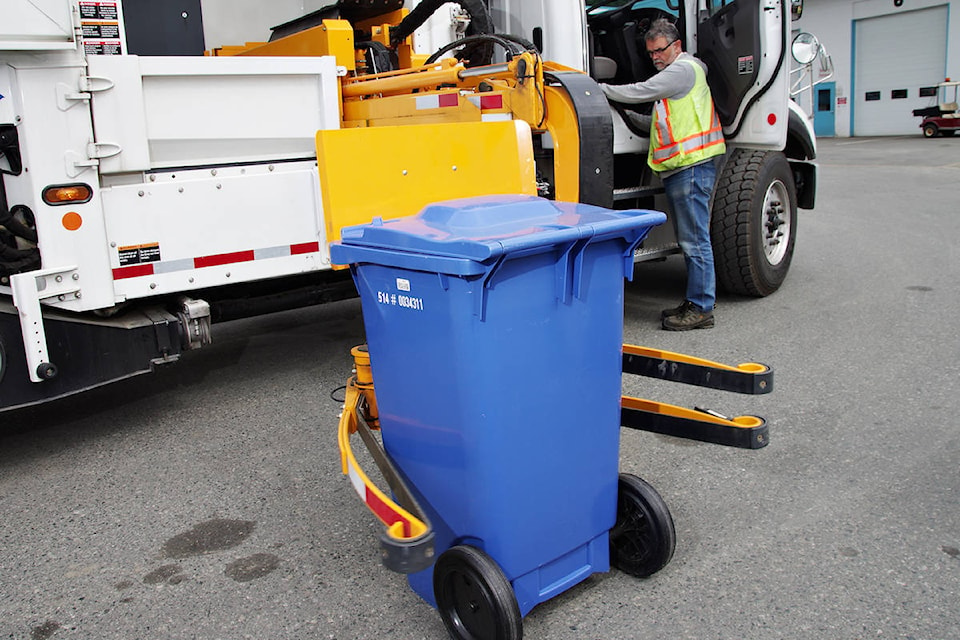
xmin=338 ymin=347 xmax=434 ymax=573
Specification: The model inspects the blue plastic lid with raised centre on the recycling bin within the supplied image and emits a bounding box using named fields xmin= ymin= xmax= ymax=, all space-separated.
xmin=334 ymin=195 xmax=666 ymax=262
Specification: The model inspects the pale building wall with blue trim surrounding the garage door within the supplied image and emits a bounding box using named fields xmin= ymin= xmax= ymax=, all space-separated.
xmin=793 ymin=0 xmax=960 ymax=137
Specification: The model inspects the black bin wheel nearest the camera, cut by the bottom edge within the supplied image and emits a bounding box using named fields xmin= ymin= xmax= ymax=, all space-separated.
xmin=433 ymin=545 xmax=523 ymax=640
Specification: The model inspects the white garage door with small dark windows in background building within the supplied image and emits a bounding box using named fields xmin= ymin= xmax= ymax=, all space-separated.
xmin=853 ymin=4 xmax=947 ymax=136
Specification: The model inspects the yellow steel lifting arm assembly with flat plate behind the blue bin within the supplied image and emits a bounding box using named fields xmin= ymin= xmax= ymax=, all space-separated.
xmin=211 ymin=10 xmax=581 ymax=224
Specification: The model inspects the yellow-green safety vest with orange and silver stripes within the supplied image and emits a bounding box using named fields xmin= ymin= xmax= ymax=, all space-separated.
xmin=647 ymin=60 xmax=727 ymax=171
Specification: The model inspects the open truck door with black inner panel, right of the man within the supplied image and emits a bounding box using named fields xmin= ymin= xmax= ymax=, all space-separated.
xmin=697 ymin=0 xmax=789 ymax=147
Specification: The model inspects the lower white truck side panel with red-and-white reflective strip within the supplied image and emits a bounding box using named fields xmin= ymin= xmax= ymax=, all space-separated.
xmin=102 ymin=160 xmax=330 ymax=302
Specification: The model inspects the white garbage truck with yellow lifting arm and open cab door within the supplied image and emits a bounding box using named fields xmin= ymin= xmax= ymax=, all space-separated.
xmin=0 ymin=0 xmax=817 ymax=411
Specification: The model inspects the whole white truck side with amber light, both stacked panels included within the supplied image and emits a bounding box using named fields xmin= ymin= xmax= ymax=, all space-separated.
xmin=0 ymin=52 xmax=340 ymax=311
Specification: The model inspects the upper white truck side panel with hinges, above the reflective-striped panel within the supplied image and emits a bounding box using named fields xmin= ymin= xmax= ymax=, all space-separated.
xmin=89 ymin=56 xmax=340 ymax=174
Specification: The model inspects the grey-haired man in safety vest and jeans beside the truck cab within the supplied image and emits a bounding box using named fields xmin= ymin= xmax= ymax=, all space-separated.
xmin=600 ymin=18 xmax=726 ymax=331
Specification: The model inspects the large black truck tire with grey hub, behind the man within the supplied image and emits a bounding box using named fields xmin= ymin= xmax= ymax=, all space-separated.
xmin=710 ymin=149 xmax=797 ymax=297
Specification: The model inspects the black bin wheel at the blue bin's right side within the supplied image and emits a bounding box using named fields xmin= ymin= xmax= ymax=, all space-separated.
xmin=610 ymin=473 xmax=677 ymax=578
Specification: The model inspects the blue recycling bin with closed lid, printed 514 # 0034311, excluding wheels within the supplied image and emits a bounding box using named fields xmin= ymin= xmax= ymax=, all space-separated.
xmin=330 ymin=196 xmax=666 ymax=615
